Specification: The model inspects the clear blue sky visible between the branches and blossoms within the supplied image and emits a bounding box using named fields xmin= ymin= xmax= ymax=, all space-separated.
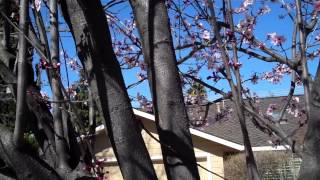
xmin=35 ymin=0 xmax=318 ymax=107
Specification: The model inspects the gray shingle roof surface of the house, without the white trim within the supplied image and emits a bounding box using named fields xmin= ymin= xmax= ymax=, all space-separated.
xmin=188 ymin=96 xmax=306 ymax=147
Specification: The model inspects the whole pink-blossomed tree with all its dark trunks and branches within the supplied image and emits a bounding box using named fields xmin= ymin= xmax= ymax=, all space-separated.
xmin=0 ymin=0 xmax=320 ymax=179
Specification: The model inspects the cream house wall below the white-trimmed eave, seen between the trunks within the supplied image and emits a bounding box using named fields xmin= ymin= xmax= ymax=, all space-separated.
xmin=95 ymin=120 xmax=224 ymax=180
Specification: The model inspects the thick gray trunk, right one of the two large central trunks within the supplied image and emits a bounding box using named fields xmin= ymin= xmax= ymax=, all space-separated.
xmin=131 ymin=0 xmax=200 ymax=179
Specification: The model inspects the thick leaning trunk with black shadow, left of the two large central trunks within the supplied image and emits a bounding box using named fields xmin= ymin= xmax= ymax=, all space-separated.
xmin=61 ymin=0 xmax=156 ymax=179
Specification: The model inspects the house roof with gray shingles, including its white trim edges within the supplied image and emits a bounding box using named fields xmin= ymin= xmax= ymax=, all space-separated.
xmin=96 ymin=96 xmax=305 ymax=151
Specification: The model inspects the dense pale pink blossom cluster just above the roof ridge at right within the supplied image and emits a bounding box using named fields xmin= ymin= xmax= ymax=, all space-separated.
xmin=262 ymin=64 xmax=292 ymax=84
